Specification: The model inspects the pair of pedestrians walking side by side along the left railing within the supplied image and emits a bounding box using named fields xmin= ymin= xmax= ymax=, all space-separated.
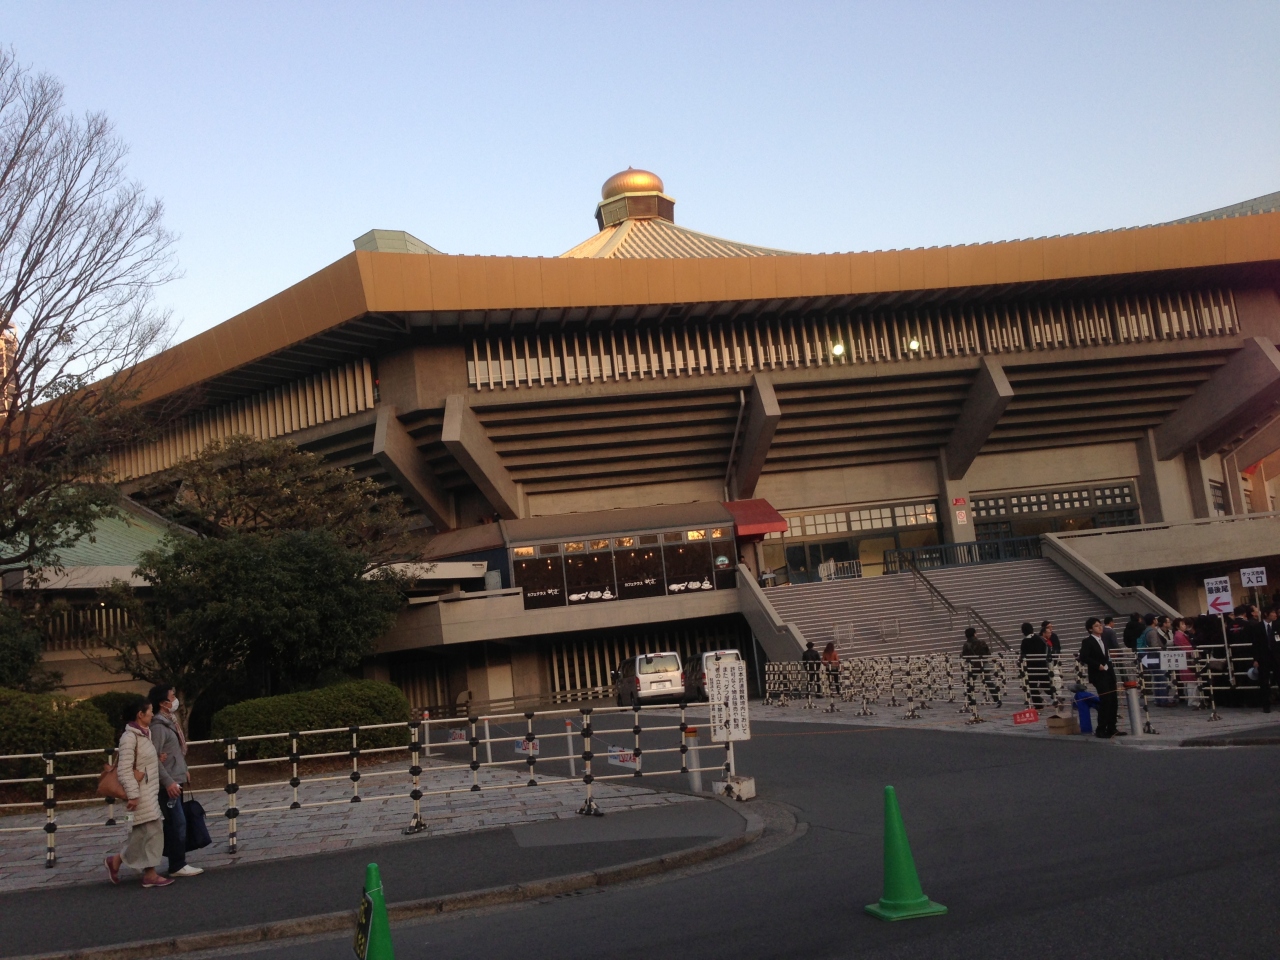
xmin=105 ymin=686 xmax=204 ymax=888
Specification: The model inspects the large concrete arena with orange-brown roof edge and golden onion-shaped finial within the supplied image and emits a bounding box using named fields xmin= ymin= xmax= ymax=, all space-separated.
xmin=45 ymin=170 xmax=1280 ymax=707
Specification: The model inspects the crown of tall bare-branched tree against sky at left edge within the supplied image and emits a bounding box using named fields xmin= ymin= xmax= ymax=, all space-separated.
xmin=0 ymin=50 xmax=175 ymax=566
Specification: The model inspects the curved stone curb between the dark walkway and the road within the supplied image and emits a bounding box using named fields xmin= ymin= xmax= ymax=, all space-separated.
xmin=12 ymin=801 xmax=764 ymax=960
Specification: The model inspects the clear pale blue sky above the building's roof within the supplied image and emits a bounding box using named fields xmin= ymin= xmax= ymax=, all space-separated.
xmin=0 ymin=0 xmax=1280 ymax=337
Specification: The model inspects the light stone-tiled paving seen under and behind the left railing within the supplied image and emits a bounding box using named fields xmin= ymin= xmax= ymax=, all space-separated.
xmin=0 ymin=758 xmax=696 ymax=892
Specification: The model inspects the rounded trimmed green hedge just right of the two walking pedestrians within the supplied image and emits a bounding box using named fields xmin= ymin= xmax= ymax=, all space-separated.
xmin=212 ymin=680 xmax=408 ymax=760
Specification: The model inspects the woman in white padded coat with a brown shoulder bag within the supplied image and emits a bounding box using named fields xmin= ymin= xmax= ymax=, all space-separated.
xmin=106 ymin=696 xmax=173 ymax=887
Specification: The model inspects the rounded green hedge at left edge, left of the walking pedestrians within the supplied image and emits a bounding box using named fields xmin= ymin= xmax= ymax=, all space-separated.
xmin=0 ymin=689 xmax=115 ymax=783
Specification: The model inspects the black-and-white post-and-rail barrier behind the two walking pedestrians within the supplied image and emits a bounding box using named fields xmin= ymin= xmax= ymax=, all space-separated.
xmin=0 ymin=703 xmax=737 ymax=868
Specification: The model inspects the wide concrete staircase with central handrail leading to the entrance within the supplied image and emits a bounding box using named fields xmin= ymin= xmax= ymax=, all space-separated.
xmin=764 ymin=559 xmax=1123 ymax=657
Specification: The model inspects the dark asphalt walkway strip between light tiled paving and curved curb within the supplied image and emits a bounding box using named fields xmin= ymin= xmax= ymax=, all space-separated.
xmin=0 ymin=794 xmax=748 ymax=957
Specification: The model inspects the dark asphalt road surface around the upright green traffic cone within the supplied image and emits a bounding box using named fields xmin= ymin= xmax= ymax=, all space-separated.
xmin=189 ymin=721 xmax=1280 ymax=960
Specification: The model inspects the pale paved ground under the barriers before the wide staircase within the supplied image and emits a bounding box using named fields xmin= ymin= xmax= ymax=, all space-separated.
xmin=665 ymin=700 xmax=1280 ymax=750
